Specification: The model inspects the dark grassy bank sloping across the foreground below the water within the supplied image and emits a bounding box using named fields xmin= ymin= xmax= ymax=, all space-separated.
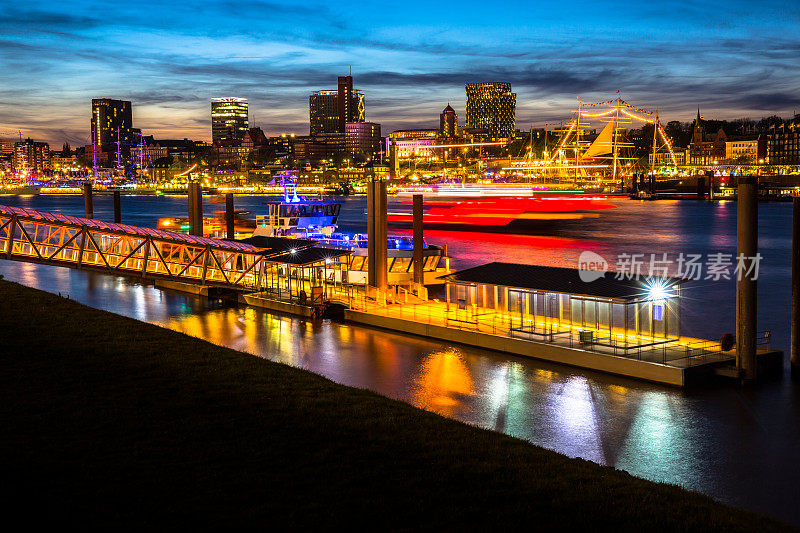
xmin=0 ymin=281 xmax=784 ymax=532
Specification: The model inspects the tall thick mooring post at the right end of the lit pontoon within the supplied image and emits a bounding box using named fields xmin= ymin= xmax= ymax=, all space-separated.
xmin=736 ymin=176 xmax=758 ymax=381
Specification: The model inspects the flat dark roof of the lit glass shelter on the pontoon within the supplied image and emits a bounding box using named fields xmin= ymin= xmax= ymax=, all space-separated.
xmin=439 ymin=262 xmax=686 ymax=300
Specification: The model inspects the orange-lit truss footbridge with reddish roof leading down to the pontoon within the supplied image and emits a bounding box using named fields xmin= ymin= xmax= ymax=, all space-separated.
xmin=0 ymin=205 xmax=334 ymax=290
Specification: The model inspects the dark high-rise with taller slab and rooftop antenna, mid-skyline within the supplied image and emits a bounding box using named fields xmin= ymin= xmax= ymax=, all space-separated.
xmin=308 ymin=76 xmax=366 ymax=135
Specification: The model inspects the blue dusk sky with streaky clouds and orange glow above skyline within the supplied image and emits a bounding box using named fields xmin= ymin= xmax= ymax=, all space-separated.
xmin=0 ymin=0 xmax=800 ymax=145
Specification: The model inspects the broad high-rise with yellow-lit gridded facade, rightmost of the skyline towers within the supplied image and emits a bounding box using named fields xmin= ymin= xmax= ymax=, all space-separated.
xmin=465 ymin=82 xmax=517 ymax=139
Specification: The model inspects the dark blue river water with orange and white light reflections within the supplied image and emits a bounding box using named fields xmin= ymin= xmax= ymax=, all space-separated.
xmin=0 ymin=195 xmax=800 ymax=525
